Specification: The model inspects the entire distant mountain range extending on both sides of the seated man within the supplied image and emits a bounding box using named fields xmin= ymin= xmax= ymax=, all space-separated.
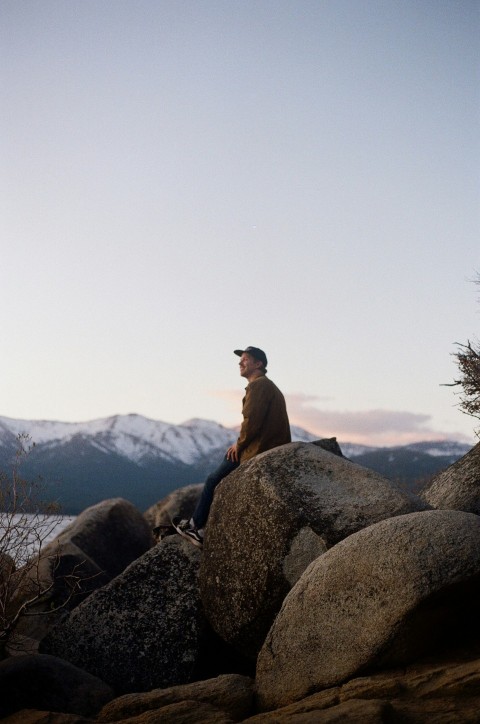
xmin=0 ymin=415 xmax=470 ymax=515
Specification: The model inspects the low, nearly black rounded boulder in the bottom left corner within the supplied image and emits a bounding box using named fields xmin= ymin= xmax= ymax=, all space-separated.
xmin=0 ymin=654 xmax=114 ymax=718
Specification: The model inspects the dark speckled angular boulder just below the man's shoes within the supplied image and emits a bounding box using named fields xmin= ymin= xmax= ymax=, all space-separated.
xmin=40 ymin=536 xmax=205 ymax=694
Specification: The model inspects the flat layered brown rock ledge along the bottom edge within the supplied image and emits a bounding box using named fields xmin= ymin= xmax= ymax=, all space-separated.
xmin=2 ymin=646 xmax=480 ymax=724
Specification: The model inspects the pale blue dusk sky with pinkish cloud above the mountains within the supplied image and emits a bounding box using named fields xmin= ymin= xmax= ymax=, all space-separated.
xmin=0 ymin=0 xmax=480 ymax=445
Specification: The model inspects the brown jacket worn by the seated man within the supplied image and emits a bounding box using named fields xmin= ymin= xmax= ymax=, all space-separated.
xmin=237 ymin=376 xmax=292 ymax=462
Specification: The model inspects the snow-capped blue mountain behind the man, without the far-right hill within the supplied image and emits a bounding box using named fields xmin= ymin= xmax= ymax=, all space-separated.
xmin=0 ymin=414 xmax=315 ymax=514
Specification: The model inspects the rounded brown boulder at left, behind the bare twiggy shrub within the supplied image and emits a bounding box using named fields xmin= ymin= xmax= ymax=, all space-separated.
xmin=7 ymin=498 xmax=154 ymax=655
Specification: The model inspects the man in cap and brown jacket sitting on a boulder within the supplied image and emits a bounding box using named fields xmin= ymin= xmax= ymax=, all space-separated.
xmin=172 ymin=347 xmax=292 ymax=547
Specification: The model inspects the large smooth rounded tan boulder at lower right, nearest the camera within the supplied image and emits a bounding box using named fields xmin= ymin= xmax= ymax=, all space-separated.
xmin=256 ymin=510 xmax=480 ymax=709
